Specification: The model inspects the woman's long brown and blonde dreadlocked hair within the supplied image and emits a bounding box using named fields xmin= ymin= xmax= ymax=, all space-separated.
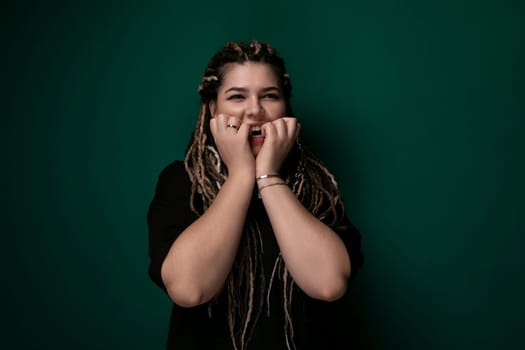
xmin=184 ymin=40 xmax=343 ymax=350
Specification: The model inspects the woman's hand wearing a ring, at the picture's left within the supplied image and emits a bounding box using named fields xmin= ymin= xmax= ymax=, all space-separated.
xmin=210 ymin=114 xmax=255 ymax=177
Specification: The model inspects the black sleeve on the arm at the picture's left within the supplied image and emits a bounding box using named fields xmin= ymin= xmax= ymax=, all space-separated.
xmin=147 ymin=161 xmax=197 ymax=290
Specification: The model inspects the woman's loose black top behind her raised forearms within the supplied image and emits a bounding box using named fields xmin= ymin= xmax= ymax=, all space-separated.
xmin=148 ymin=161 xmax=363 ymax=350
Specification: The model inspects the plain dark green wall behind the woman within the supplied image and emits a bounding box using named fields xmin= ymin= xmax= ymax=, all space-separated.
xmin=5 ymin=0 xmax=525 ymax=349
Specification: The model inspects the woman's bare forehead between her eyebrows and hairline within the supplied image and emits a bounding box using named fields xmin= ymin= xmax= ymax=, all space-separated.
xmin=221 ymin=62 xmax=279 ymax=89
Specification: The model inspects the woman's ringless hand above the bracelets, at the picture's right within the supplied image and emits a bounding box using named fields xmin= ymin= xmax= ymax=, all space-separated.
xmin=255 ymin=117 xmax=301 ymax=176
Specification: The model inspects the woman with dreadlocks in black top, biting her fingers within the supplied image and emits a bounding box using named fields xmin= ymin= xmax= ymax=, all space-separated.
xmin=148 ymin=41 xmax=362 ymax=350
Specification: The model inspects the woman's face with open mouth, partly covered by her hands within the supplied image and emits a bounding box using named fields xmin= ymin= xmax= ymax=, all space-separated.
xmin=210 ymin=62 xmax=286 ymax=156
